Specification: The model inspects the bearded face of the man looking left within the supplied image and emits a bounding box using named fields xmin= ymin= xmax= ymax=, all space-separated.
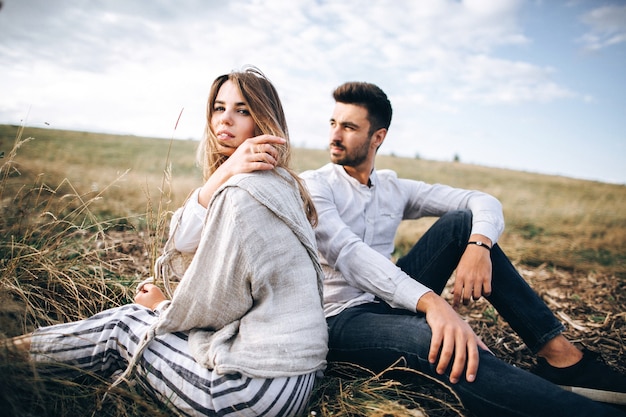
xmin=329 ymin=103 xmax=375 ymax=166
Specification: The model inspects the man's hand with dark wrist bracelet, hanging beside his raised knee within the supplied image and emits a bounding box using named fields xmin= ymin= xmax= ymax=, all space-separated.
xmin=452 ymin=235 xmax=491 ymax=308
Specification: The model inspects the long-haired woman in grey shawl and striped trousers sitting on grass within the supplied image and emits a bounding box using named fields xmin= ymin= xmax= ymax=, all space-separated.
xmin=7 ymin=68 xmax=327 ymax=416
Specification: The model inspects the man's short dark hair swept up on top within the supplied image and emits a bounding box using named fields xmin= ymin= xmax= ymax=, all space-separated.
xmin=333 ymin=81 xmax=392 ymax=135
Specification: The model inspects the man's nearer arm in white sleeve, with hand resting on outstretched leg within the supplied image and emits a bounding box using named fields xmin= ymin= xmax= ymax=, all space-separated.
xmin=307 ymin=171 xmax=487 ymax=383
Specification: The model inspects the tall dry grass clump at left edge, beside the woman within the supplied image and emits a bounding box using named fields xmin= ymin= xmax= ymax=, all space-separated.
xmin=0 ymin=133 xmax=128 ymax=329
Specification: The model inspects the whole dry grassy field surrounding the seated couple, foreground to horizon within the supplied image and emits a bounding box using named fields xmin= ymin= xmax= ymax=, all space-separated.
xmin=0 ymin=125 xmax=626 ymax=416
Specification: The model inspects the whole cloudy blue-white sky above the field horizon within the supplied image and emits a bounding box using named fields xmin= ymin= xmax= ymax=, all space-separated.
xmin=0 ymin=0 xmax=626 ymax=184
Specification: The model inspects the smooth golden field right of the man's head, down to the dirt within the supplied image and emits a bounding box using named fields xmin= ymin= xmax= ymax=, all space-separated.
xmin=370 ymin=156 xmax=626 ymax=278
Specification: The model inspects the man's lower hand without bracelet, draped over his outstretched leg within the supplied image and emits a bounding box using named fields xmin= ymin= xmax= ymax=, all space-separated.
xmin=417 ymin=292 xmax=488 ymax=384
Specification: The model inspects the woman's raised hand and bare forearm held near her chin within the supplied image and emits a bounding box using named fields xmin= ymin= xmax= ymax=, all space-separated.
xmin=198 ymin=135 xmax=287 ymax=207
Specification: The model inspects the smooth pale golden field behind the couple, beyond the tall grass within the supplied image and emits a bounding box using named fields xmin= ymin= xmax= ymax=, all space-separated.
xmin=0 ymin=126 xmax=626 ymax=277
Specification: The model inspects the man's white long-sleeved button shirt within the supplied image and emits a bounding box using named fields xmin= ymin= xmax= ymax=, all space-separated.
xmin=301 ymin=164 xmax=504 ymax=317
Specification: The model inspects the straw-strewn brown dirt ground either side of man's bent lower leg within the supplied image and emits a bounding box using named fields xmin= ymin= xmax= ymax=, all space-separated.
xmin=459 ymin=265 xmax=626 ymax=372
